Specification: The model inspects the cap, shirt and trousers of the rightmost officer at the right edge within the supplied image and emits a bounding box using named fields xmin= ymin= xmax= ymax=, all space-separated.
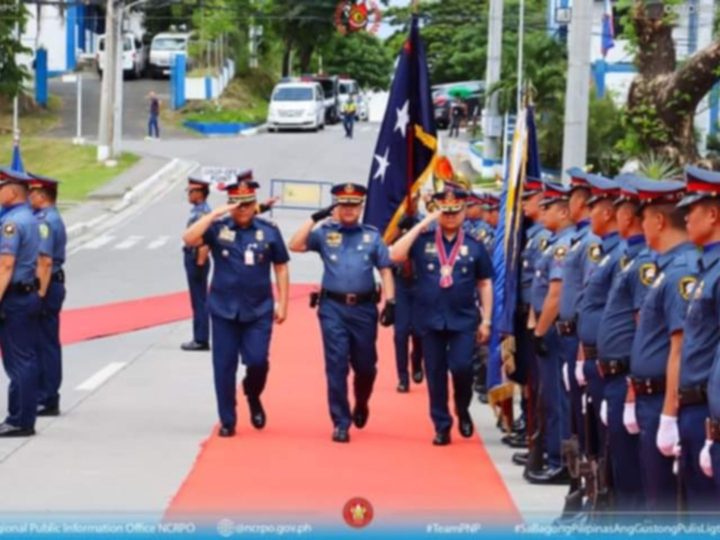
xmin=678 ymin=167 xmax=720 ymax=511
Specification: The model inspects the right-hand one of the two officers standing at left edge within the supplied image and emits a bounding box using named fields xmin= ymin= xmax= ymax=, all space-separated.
xmin=28 ymin=174 xmax=67 ymax=416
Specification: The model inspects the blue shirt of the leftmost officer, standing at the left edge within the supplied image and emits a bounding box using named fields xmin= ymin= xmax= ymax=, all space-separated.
xmin=0 ymin=203 xmax=40 ymax=284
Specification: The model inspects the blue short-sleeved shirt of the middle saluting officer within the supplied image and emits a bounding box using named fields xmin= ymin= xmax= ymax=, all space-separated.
xmin=307 ymin=221 xmax=392 ymax=294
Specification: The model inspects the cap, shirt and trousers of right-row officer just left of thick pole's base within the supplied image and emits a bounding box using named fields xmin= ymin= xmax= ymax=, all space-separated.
xmin=528 ymin=182 xmax=574 ymax=482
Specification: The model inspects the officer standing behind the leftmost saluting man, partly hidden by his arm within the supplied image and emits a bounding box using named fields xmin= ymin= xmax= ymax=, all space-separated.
xmin=180 ymin=176 xmax=212 ymax=351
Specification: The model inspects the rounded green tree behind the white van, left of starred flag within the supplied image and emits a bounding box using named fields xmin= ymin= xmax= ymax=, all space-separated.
xmin=323 ymin=32 xmax=393 ymax=88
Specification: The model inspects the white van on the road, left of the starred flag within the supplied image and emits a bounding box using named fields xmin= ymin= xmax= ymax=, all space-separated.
xmin=267 ymin=82 xmax=325 ymax=131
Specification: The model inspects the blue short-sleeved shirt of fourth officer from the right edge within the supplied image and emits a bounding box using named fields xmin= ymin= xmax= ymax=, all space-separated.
xmin=578 ymin=232 xmax=624 ymax=345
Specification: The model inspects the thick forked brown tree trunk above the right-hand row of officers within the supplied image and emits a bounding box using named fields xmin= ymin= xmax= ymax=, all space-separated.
xmin=622 ymin=0 xmax=720 ymax=165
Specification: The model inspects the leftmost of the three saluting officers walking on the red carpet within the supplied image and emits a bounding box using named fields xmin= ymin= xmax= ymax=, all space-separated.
xmin=183 ymin=175 xmax=290 ymax=437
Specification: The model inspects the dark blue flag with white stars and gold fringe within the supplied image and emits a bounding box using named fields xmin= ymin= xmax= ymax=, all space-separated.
xmin=363 ymin=15 xmax=437 ymax=240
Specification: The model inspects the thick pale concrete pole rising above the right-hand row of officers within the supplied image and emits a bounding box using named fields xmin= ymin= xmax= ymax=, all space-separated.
xmin=562 ymin=0 xmax=593 ymax=178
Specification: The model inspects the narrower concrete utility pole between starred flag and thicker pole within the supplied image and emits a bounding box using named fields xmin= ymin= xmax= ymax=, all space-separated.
xmin=483 ymin=0 xmax=504 ymax=176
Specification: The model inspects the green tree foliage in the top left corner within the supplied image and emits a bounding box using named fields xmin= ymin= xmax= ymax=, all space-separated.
xmin=0 ymin=0 xmax=30 ymax=99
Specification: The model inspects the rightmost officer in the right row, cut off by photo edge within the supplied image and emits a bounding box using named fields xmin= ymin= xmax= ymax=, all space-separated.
xmin=668 ymin=167 xmax=720 ymax=512
